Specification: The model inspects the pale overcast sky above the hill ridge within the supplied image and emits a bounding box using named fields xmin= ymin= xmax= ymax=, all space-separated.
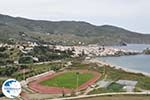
xmin=0 ymin=0 xmax=150 ymax=34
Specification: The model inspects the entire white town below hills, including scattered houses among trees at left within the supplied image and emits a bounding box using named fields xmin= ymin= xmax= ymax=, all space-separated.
xmin=0 ymin=41 xmax=141 ymax=64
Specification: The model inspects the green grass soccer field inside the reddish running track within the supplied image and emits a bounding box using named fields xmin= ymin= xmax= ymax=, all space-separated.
xmin=40 ymin=71 xmax=94 ymax=89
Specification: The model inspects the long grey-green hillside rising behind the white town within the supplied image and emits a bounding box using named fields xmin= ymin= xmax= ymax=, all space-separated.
xmin=0 ymin=14 xmax=150 ymax=45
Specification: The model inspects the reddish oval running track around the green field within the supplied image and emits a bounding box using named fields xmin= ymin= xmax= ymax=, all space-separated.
xmin=28 ymin=70 xmax=100 ymax=94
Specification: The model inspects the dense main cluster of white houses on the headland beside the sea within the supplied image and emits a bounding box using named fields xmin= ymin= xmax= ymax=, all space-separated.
xmin=55 ymin=45 xmax=138 ymax=57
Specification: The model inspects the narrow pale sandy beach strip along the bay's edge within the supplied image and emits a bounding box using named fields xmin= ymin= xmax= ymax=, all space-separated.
xmin=89 ymin=58 xmax=150 ymax=76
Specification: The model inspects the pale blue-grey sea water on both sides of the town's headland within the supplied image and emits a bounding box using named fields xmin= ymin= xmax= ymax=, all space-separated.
xmin=97 ymin=44 xmax=150 ymax=73
